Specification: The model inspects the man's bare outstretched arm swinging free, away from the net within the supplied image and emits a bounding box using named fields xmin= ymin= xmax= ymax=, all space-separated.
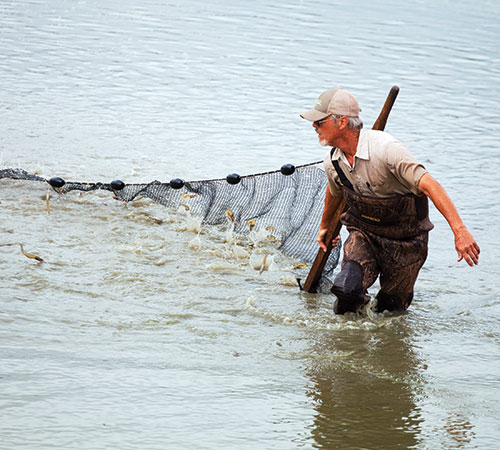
xmin=418 ymin=173 xmax=479 ymax=266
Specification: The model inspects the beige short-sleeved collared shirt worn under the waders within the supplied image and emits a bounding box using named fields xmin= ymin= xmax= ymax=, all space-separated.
xmin=324 ymin=130 xmax=427 ymax=197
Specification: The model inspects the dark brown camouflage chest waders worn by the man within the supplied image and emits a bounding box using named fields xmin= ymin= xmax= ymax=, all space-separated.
xmin=331 ymin=161 xmax=433 ymax=314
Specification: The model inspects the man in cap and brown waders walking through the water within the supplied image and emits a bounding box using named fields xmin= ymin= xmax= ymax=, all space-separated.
xmin=301 ymin=89 xmax=479 ymax=314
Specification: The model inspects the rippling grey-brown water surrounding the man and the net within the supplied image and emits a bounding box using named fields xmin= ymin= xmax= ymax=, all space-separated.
xmin=0 ymin=0 xmax=500 ymax=449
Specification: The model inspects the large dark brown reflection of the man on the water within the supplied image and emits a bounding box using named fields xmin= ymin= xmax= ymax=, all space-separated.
xmin=307 ymin=316 xmax=424 ymax=449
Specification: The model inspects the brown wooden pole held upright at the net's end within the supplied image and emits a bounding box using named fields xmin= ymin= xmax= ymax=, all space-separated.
xmin=302 ymin=86 xmax=399 ymax=293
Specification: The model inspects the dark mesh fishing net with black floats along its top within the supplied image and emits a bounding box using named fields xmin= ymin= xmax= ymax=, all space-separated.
xmin=0 ymin=162 xmax=340 ymax=289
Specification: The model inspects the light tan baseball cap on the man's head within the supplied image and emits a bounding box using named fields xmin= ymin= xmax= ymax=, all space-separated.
xmin=300 ymin=88 xmax=361 ymax=122
